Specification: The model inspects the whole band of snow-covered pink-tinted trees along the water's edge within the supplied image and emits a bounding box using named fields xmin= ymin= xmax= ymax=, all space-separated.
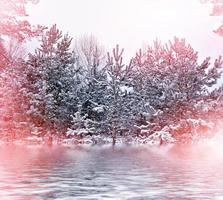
xmin=0 ymin=0 xmax=223 ymax=144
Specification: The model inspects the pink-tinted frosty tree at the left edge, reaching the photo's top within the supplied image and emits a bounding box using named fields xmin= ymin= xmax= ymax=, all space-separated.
xmin=0 ymin=0 xmax=44 ymax=139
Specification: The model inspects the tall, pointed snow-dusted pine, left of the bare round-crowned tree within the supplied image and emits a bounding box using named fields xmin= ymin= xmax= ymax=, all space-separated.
xmin=24 ymin=25 xmax=76 ymax=134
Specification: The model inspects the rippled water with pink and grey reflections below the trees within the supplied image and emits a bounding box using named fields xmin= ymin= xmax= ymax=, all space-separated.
xmin=0 ymin=145 xmax=223 ymax=200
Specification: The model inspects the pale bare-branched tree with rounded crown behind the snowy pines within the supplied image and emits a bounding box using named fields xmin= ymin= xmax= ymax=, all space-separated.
xmin=74 ymin=36 xmax=107 ymax=109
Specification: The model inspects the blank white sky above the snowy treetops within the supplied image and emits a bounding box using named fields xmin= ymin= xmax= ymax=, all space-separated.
xmin=28 ymin=0 xmax=223 ymax=58
